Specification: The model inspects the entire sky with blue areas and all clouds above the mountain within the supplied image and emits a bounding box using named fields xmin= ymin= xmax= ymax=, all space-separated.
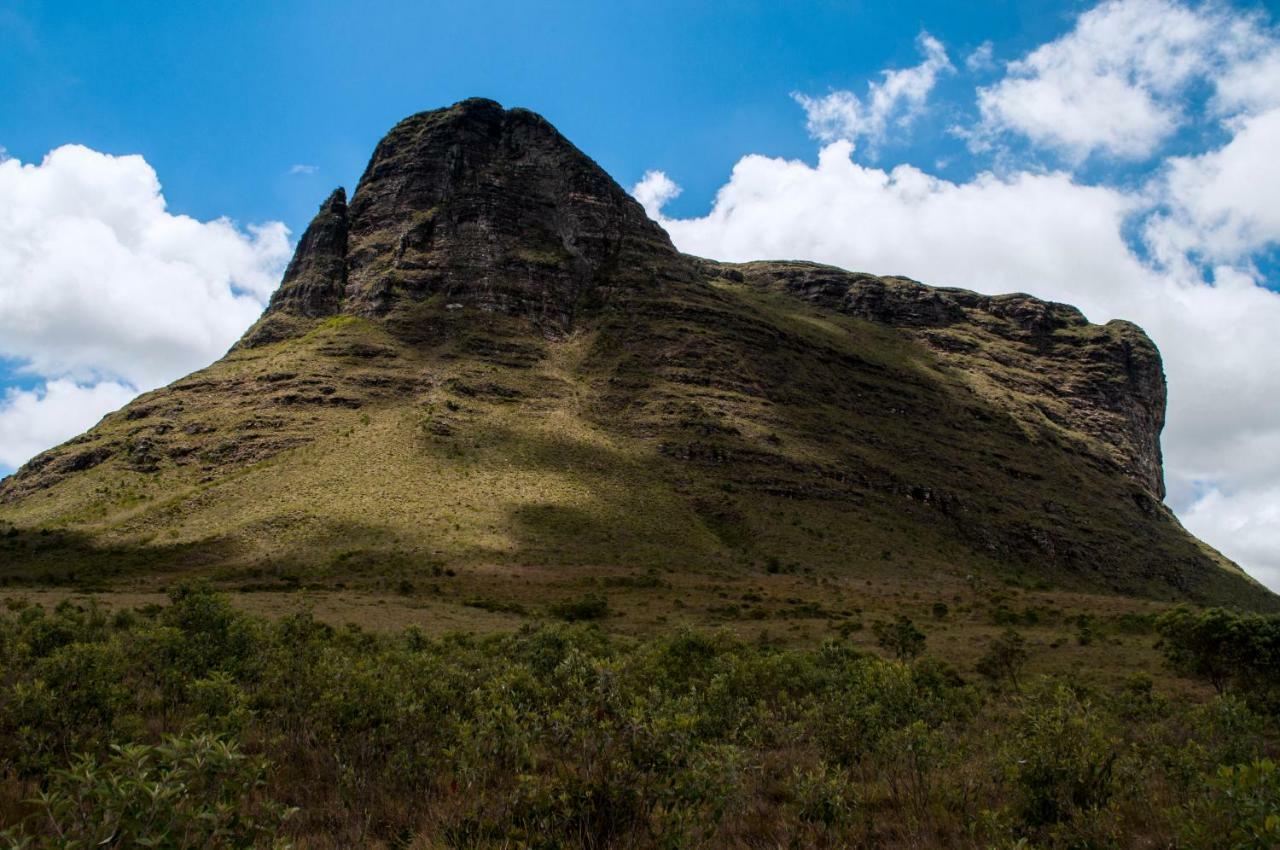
xmin=0 ymin=0 xmax=1280 ymax=586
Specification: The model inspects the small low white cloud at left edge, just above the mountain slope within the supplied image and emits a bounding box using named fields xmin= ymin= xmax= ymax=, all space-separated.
xmin=0 ymin=379 xmax=137 ymax=467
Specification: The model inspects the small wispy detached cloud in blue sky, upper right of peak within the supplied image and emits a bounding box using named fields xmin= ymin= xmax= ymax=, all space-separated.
xmin=792 ymin=32 xmax=952 ymax=147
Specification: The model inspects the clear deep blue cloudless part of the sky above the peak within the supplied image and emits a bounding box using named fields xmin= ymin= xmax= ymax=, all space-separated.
xmin=0 ymin=0 xmax=1157 ymax=232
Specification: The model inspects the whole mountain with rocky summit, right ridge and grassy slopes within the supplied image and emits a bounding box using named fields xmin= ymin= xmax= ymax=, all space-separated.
xmin=0 ymin=100 xmax=1277 ymax=609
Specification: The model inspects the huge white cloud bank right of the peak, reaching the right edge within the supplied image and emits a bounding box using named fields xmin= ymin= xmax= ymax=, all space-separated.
xmin=645 ymin=0 xmax=1280 ymax=590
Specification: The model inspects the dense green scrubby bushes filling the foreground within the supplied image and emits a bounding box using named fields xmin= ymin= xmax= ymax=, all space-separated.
xmin=0 ymin=588 xmax=1280 ymax=849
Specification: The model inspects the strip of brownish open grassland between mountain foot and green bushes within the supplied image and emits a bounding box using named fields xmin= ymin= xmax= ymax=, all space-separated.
xmin=0 ymin=566 xmax=1204 ymax=694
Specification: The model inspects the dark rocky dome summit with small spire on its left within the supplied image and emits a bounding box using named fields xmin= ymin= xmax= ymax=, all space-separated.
xmin=246 ymin=99 xmax=689 ymax=344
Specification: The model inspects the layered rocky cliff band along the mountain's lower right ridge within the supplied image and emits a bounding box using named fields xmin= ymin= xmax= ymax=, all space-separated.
xmin=704 ymin=262 xmax=1166 ymax=499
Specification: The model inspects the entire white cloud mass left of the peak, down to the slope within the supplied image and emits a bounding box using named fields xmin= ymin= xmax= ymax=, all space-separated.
xmin=0 ymin=145 xmax=289 ymax=466
